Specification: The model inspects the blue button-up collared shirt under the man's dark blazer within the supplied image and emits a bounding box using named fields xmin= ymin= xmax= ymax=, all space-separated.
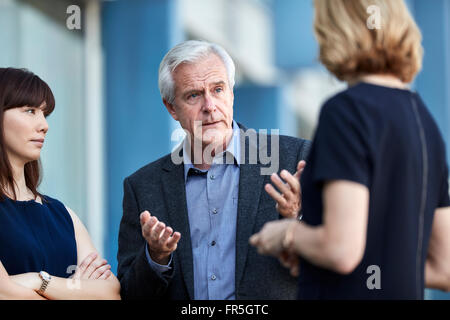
xmin=146 ymin=121 xmax=241 ymax=300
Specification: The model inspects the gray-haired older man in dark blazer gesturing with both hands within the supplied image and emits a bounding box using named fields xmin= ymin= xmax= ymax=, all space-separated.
xmin=118 ymin=41 xmax=310 ymax=300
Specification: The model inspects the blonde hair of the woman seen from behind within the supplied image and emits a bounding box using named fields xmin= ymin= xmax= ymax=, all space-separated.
xmin=314 ymin=0 xmax=423 ymax=83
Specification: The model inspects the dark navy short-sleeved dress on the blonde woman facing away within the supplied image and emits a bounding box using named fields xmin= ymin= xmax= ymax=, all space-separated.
xmin=299 ymin=83 xmax=450 ymax=299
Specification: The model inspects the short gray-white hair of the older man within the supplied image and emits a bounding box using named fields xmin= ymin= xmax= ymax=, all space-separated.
xmin=158 ymin=40 xmax=235 ymax=103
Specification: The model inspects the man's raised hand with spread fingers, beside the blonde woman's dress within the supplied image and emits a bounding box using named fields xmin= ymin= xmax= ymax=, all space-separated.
xmin=264 ymin=160 xmax=306 ymax=218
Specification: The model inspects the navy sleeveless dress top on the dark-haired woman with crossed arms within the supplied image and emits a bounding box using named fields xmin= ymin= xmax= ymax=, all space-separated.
xmin=0 ymin=196 xmax=77 ymax=278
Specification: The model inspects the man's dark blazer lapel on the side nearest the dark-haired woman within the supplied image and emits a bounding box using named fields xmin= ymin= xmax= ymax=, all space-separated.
xmin=161 ymin=150 xmax=194 ymax=299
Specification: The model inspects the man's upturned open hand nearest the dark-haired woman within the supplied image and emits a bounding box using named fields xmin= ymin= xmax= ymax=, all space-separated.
xmin=140 ymin=210 xmax=181 ymax=265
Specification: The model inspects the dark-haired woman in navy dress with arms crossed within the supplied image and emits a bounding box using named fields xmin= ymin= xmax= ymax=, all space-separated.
xmin=0 ymin=68 xmax=120 ymax=300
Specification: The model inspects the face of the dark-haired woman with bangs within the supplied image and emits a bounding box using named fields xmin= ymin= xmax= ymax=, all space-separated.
xmin=3 ymin=103 xmax=48 ymax=164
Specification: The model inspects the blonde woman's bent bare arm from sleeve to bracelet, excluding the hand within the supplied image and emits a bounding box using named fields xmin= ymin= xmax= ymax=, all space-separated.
xmin=294 ymin=180 xmax=369 ymax=274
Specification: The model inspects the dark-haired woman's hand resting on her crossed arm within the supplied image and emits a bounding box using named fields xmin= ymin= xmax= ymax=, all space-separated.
xmin=71 ymin=252 xmax=111 ymax=280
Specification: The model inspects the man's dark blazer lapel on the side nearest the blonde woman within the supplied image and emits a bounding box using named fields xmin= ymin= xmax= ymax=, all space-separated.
xmin=235 ymin=128 xmax=265 ymax=290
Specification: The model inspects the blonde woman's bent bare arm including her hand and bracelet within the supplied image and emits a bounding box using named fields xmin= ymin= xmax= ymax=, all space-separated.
xmin=250 ymin=180 xmax=369 ymax=274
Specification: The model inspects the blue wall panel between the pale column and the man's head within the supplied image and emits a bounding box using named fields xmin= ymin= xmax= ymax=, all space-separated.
xmin=102 ymin=0 xmax=181 ymax=272
